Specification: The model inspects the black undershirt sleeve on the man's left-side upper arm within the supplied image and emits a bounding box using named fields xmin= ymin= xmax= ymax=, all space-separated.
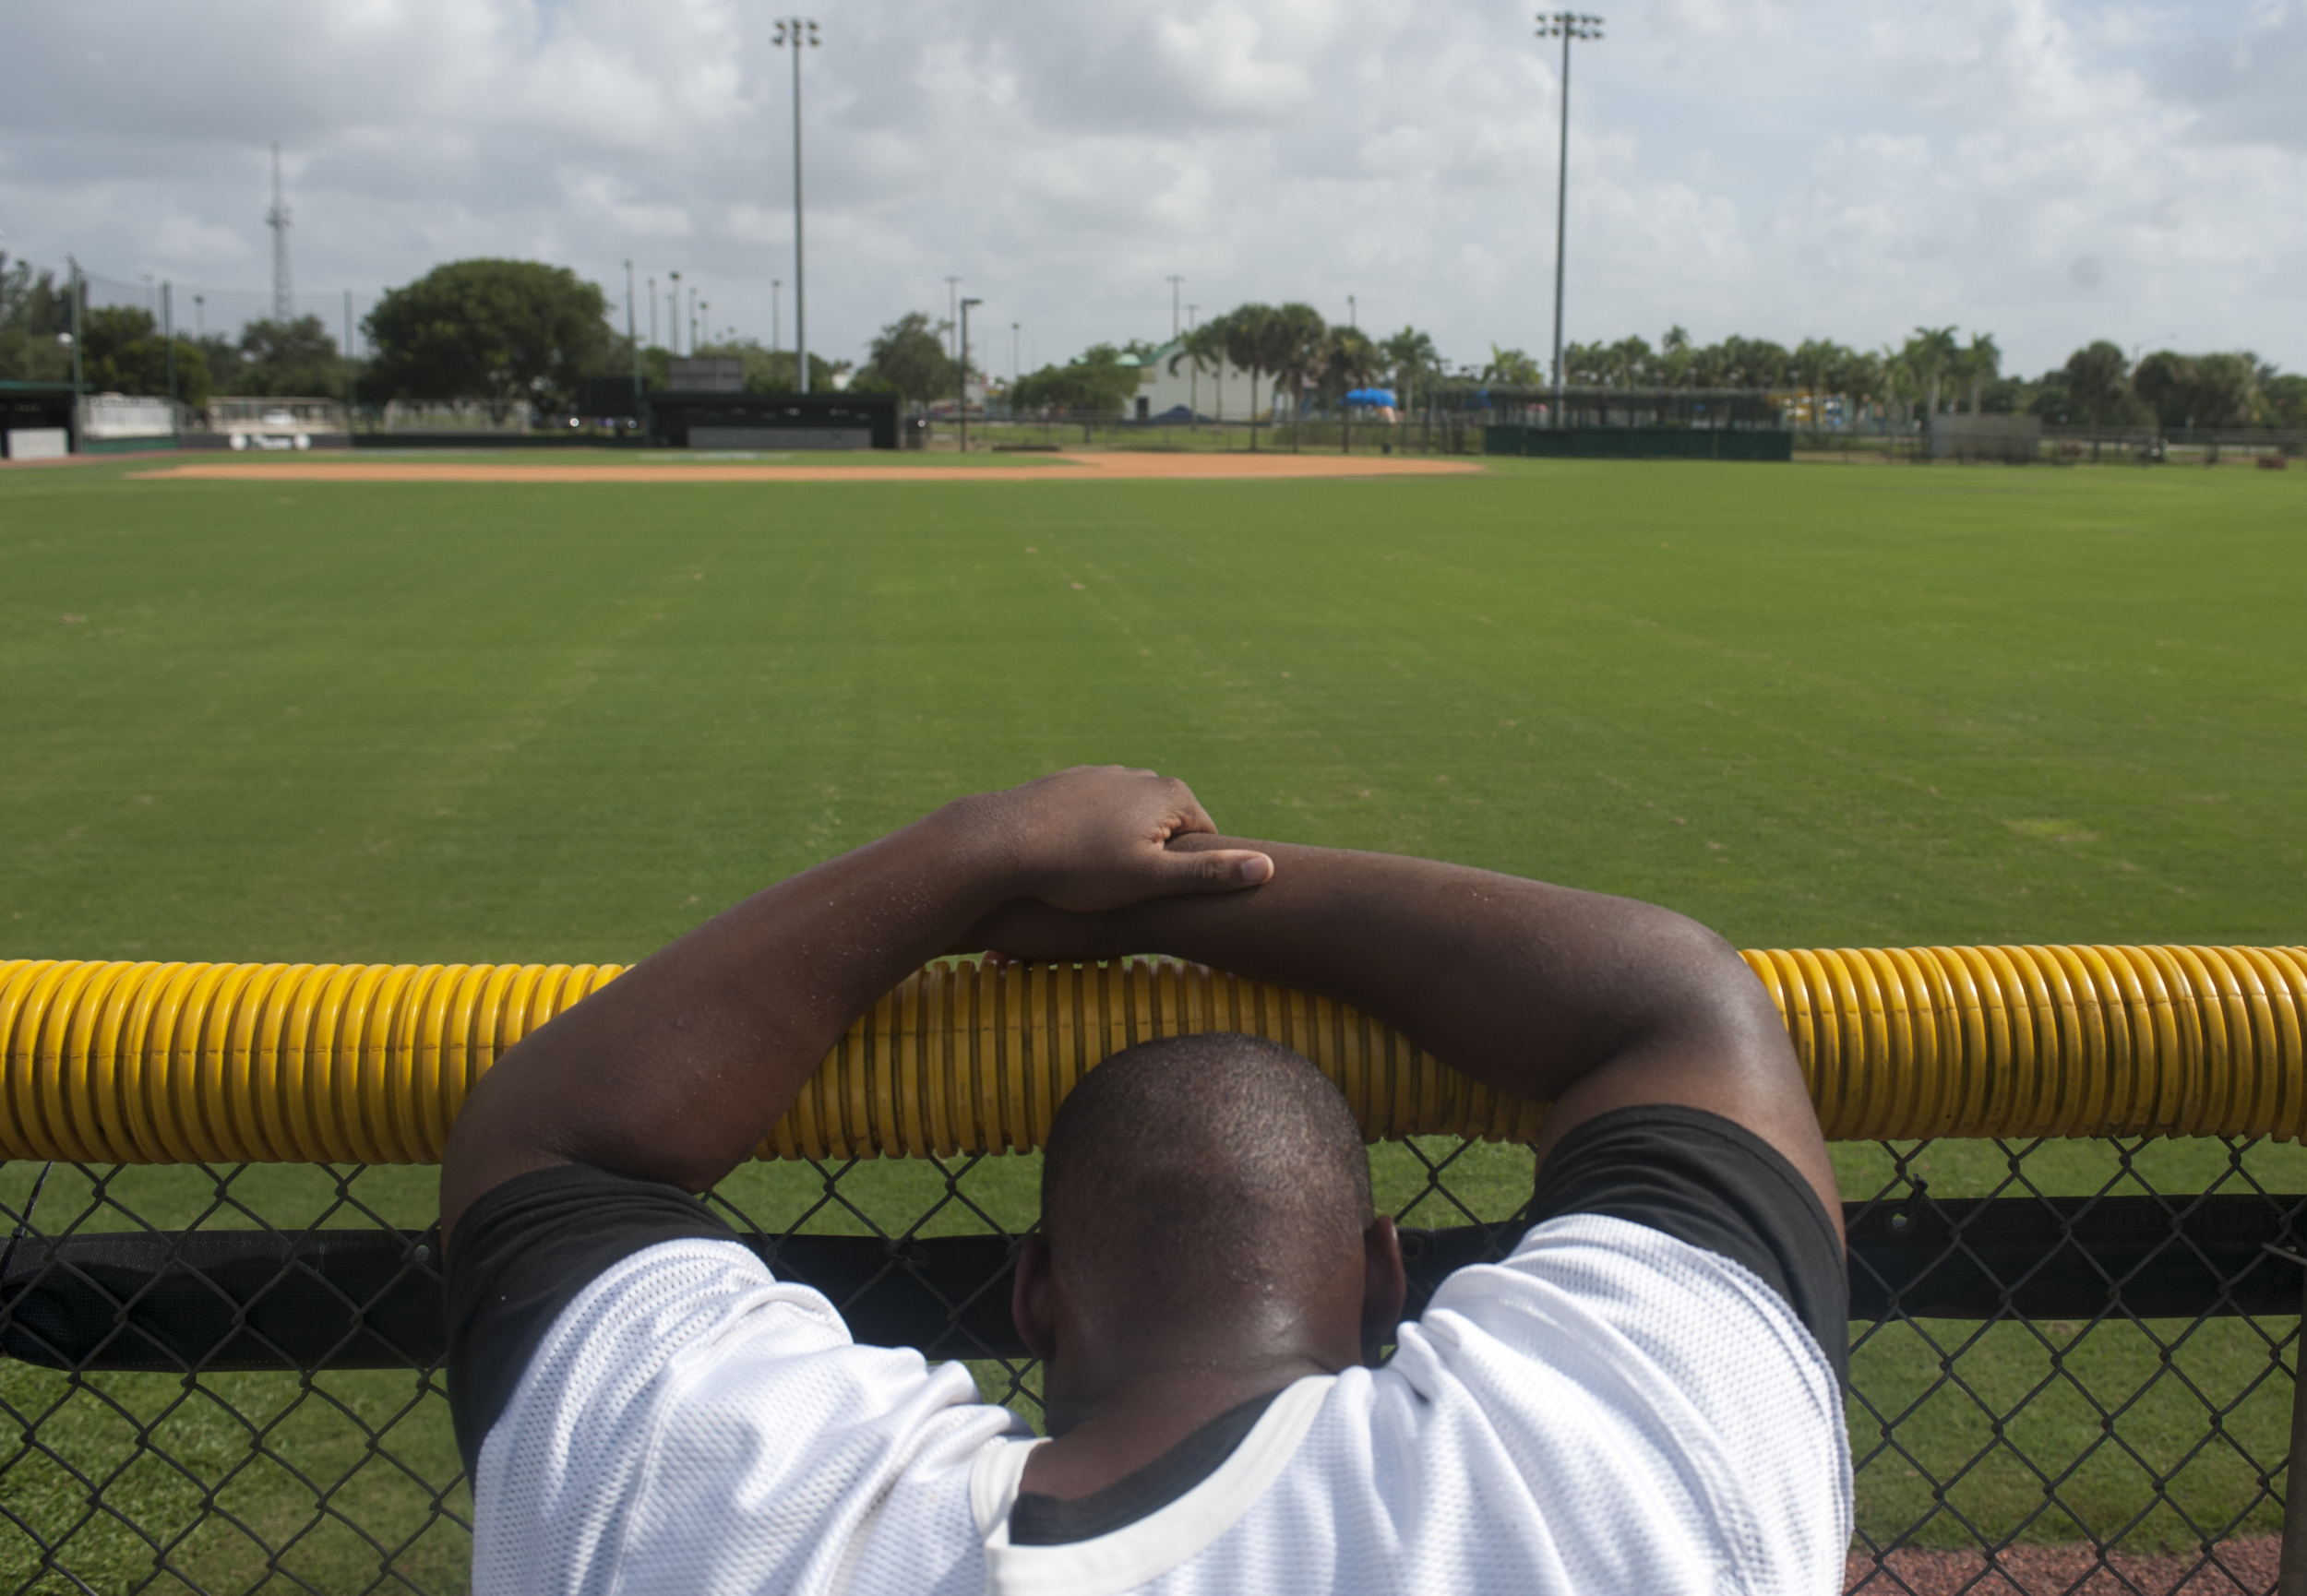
xmin=446 ymin=1165 xmax=738 ymax=1474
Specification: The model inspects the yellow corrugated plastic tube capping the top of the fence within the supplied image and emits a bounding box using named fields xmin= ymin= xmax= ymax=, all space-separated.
xmin=0 ymin=946 xmax=2307 ymax=1165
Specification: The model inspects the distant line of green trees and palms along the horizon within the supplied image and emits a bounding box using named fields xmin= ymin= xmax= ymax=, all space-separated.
xmin=0 ymin=256 xmax=2307 ymax=432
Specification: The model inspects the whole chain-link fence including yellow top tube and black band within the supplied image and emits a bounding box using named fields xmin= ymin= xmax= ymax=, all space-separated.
xmin=0 ymin=948 xmax=2307 ymax=1591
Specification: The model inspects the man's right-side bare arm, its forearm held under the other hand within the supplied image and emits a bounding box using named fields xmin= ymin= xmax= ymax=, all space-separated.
xmin=976 ymin=838 xmax=1832 ymax=1207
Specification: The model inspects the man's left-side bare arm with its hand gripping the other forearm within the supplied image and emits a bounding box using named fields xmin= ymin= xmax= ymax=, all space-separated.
xmin=441 ymin=766 xmax=1272 ymax=1225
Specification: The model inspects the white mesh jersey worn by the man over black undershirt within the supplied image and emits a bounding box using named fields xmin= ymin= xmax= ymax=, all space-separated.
xmin=473 ymin=1213 xmax=1850 ymax=1596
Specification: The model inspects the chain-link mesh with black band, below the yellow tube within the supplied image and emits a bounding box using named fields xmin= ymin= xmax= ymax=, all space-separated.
xmin=0 ymin=1137 xmax=2307 ymax=1596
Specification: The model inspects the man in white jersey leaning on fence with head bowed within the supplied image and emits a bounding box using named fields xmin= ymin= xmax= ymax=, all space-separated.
xmin=441 ymin=768 xmax=1850 ymax=1596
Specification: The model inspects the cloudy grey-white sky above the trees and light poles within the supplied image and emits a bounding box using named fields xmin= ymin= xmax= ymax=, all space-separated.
xmin=0 ymin=0 xmax=2307 ymax=372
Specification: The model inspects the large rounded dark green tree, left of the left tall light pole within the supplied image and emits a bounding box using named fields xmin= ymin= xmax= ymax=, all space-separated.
xmin=360 ymin=261 xmax=614 ymax=420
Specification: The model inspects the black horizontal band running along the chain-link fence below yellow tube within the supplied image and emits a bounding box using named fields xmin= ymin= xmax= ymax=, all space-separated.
xmin=0 ymin=1195 xmax=2307 ymax=1373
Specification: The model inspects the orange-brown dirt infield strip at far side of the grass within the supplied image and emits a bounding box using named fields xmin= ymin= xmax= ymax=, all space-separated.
xmin=129 ymin=450 xmax=1481 ymax=484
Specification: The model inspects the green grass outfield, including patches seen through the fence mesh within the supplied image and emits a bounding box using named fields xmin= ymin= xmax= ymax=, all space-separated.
xmin=0 ymin=457 xmax=2307 ymax=1587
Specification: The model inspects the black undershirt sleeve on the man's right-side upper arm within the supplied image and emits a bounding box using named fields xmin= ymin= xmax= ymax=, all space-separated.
xmin=1530 ymin=1102 xmax=1850 ymax=1379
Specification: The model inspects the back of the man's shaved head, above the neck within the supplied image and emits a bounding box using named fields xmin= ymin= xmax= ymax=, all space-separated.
xmin=1041 ymin=1033 xmax=1370 ymax=1315
